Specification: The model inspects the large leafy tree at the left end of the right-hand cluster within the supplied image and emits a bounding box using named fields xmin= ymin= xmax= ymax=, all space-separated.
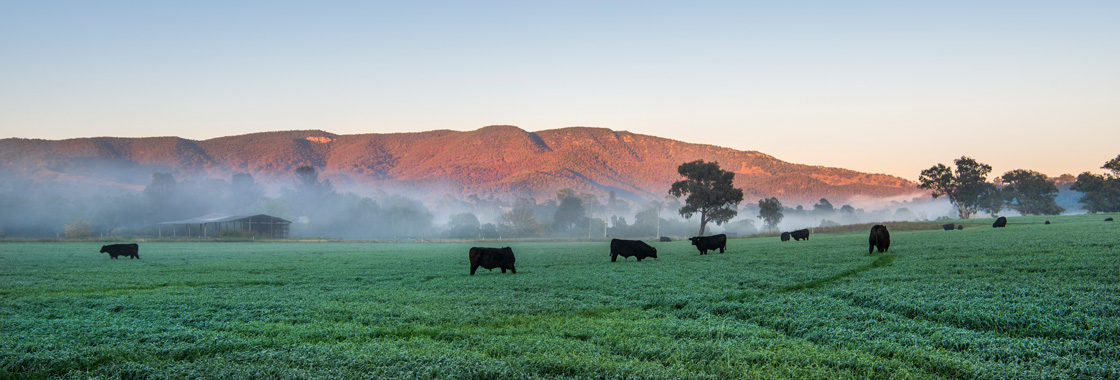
xmin=918 ymin=156 xmax=998 ymax=219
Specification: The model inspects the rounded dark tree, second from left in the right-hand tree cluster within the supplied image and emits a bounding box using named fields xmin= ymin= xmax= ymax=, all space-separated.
xmin=1000 ymin=169 xmax=1065 ymax=215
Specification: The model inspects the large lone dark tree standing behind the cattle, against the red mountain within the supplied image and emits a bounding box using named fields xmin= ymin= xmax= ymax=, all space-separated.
xmin=669 ymin=159 xmax=743 ymax=237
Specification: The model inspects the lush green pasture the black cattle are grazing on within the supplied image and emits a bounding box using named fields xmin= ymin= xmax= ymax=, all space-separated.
xmin=0 ymin=215 xmax=1120 ymax=379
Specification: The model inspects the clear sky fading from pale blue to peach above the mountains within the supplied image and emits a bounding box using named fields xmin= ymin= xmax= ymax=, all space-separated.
xmin=0 ymin=0 xmax=1120 ymax=179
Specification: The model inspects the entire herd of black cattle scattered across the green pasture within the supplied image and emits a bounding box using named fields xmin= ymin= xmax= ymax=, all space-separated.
xmin=101 ymin=216 xmax=1112 ymax=276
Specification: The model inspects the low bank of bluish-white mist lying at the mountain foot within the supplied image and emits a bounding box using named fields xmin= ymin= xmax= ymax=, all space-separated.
xmin=0 ymin=163 xmax=1080 ymax=240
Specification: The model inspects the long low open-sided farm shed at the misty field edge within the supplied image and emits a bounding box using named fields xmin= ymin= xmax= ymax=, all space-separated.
xmin=159 ymin=214 xmax=291 ymax=239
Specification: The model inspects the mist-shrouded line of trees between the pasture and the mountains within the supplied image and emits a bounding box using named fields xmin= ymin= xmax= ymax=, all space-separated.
xmin=0 ymin=156 xmax=1120 ymax=239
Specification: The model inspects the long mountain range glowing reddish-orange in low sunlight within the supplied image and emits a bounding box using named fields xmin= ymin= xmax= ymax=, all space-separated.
xmin=0 ymin=126 xmax=922 ymax=205
